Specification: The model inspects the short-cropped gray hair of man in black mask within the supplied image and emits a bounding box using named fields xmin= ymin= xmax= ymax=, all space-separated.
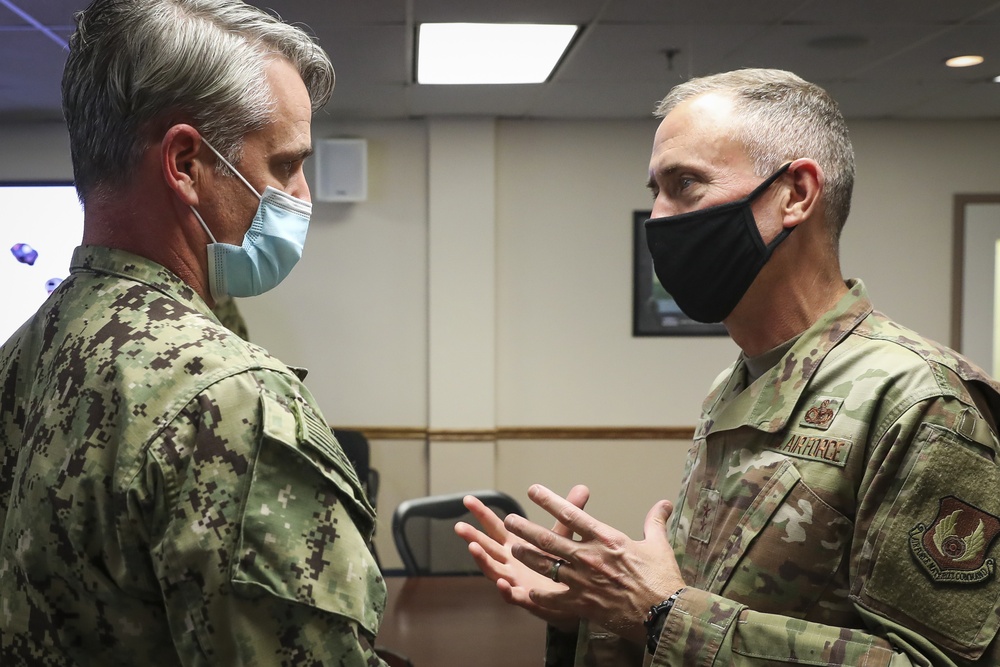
xmin=656 ymin=69 xmax=854 ymax=248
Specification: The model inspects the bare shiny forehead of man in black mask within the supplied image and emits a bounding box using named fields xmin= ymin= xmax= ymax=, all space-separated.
xmin=650 ymin=93 xmax=748 ymax=174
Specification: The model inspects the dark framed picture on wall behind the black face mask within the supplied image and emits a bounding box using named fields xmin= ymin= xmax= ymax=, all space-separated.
xmin=632 ymin=211 xmax=726 ymax=336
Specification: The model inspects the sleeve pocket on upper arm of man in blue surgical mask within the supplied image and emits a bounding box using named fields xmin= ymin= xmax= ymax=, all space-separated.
xmin=231 ymin=392 xmax=385 ymax=634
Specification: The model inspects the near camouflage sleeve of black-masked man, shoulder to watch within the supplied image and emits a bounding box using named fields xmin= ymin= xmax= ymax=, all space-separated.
xmin=652 ymin=397 xmax=1000 ymax=667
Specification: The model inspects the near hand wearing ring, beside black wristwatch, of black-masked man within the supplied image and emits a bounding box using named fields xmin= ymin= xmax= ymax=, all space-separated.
xmin=504 ymin=484 xmax=684 ymax=642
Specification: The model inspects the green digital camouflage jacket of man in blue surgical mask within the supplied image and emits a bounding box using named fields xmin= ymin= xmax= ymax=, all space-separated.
xmin=0 ymin=247 xmax=385 ymax=667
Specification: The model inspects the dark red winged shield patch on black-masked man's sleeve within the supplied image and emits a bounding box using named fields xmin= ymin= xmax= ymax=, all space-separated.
xmin=910 ymin=496 xmax=1000 ymax=584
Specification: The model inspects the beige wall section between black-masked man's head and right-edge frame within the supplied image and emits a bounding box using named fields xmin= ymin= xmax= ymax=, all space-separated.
xmin=842 ymin=121 xmax=1000 ymax=344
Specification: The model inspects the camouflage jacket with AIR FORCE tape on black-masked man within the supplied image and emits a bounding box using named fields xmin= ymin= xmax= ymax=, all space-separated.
xmin=548 ymin=282 xmax=1000 ymax=667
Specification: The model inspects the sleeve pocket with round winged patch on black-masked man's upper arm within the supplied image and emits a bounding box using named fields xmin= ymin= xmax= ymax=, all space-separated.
xmin=861 ymin=424 xmax=1000 ymax=660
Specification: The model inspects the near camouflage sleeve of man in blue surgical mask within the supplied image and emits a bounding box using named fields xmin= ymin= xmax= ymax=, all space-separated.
xmin=143 ymin=371 xmax=385 ymax=667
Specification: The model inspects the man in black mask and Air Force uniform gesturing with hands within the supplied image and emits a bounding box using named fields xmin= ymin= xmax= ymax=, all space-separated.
xmin=457 ymin=70 xmax=1000 ymax=667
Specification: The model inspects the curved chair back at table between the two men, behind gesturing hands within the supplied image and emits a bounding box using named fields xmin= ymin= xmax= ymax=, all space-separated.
xmin=392 ymin=490 xmax=524 ymax=576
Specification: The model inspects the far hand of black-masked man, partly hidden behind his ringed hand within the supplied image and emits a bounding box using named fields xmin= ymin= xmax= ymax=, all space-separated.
xmin=455 ymin=485 xmax=590 ymax=632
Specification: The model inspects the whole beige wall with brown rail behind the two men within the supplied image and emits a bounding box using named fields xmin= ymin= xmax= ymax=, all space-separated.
xmin=0 ymin=115 xmax=1000 ymax=566
